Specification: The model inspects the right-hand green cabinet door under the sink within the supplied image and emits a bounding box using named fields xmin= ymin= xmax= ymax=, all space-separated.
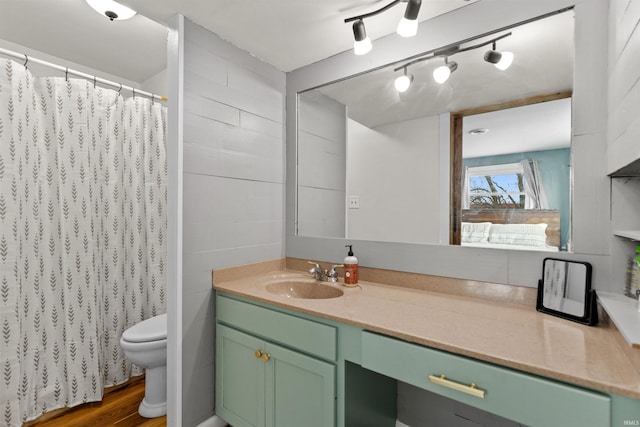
xmin=265 ymin=343 xmax=336 ymax=427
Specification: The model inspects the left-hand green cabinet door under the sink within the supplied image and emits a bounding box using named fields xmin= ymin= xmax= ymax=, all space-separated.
xmin=216 ymin=325 xmax=265 ymax=427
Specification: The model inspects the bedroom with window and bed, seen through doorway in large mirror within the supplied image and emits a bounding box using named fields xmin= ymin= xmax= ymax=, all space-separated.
xmin=452 ymin=92 xmax=571 ymax=252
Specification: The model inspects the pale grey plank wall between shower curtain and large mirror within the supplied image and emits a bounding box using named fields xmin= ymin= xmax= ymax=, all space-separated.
xmin=182 ymin=20 xmax=285 ymax=426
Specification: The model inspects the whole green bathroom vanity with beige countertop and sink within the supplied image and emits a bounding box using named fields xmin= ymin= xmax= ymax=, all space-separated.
xmin=214 ymin=260 xmax=640 ymax=427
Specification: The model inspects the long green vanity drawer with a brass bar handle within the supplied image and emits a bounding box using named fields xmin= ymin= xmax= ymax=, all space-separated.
xmin=362 ymin=332 xmax=611 ymax=427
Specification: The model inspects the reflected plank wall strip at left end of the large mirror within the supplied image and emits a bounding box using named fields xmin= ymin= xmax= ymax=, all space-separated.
xmin=298 ymin=91 xmax=347 ymax=237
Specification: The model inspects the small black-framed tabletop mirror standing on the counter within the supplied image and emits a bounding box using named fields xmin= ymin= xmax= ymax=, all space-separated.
xmin=537 ymin=258 xmax=595 ymax=324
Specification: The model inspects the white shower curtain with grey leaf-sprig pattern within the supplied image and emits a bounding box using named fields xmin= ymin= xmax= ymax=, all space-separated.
xmin=0 ymin=59 xmax=167 ymax=426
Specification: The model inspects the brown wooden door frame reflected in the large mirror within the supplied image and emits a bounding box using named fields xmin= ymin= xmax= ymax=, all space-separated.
xmin=449 ymin=91 xmax=573 ymax=245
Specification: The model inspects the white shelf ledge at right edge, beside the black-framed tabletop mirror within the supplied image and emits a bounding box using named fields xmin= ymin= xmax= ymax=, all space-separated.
xmin=596 ymin=291 xmax=640 ymax=348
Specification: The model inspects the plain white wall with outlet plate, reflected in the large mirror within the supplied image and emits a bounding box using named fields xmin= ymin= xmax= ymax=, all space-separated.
xmin=347 ymin=116 xmax=440 ymax=244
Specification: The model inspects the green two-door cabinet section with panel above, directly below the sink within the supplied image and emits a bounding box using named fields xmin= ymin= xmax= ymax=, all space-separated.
xmin=216 ymin=296 xmax=336 ymax=427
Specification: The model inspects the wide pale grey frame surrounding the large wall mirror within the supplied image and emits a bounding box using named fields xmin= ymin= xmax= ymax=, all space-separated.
xmin=284 ymin=0 xmax=612 ymax=288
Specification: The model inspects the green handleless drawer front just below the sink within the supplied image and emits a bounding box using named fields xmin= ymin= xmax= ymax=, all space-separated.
xmin=216 ymin=294 xmax=337 ymax=361
